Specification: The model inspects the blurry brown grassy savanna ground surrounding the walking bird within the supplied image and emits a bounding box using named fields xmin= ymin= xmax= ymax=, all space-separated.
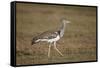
xmin=16 ymin=3 xmax=96 ymax=65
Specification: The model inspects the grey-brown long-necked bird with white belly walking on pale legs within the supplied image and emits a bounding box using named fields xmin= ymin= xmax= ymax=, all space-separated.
xmin=31 ymin=19 xmax=70 ymax=57
